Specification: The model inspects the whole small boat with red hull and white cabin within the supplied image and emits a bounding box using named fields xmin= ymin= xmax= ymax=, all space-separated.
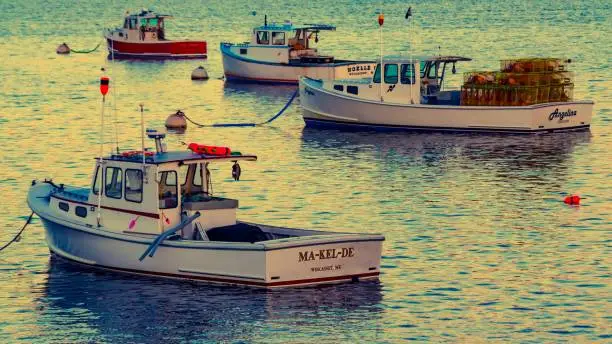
xmin=104 ymin=10 xmax=206 ymax=58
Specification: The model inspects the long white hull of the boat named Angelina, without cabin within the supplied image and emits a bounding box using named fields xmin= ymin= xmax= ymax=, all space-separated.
xmin=300 ymin=78 xmax=593 ymax=133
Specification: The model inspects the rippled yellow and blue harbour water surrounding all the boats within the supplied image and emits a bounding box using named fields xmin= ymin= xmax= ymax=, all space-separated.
xmin=0 ymin=0 xmax=612 ymax=343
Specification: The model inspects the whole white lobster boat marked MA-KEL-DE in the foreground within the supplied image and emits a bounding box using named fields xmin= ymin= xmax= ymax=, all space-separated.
xmin=28 ymin=132 xmax=384 ymax=288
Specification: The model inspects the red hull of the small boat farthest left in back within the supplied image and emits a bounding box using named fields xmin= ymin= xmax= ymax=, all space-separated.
xmin=107 ymin=39 xmax=206 ymax=58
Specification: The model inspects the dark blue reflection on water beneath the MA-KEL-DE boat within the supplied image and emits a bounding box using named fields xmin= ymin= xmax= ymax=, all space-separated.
xmin=37 ymin=257 xmax=382 ymax=342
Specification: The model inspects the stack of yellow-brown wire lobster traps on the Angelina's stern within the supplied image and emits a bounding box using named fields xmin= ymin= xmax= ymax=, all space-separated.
xmin=461 ymin=58 xmax=574 ymax=106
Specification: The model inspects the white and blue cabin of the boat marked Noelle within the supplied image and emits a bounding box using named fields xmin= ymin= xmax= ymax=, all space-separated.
xmin=239 ymin=22 xmax=336 ymax=64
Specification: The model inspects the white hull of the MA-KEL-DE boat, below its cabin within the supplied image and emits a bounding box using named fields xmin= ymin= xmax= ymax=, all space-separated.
xmin=28 ymin=184 xmax=384 ymax=288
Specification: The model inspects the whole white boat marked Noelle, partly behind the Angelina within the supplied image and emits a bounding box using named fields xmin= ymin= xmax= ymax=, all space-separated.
xmin=220 ymin=21 xmax=375 ymax=84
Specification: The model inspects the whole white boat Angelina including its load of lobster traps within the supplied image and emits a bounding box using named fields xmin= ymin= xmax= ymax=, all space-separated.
xmin=299 ymin=56 xmax=594 ymax=133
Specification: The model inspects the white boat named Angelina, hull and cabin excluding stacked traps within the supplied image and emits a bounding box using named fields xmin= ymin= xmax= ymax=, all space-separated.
xmin=300 ymin=56 xmax=593 ymax=133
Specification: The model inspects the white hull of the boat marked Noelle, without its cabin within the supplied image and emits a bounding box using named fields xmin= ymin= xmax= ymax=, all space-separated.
xmin=221 ymin=43 xmax=374 ymax=84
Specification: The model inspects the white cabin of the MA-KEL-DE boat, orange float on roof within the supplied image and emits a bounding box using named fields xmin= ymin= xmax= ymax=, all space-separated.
xmin=52 ymin=131 xmax=257 ymax=238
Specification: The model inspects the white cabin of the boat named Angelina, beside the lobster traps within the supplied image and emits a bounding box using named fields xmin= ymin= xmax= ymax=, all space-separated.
xmin=325 ymin=56 xmax=471 ymax=105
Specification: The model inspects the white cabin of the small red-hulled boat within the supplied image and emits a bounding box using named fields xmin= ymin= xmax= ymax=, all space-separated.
xmin=111 ymin=10 xmax=171 ymax=42
